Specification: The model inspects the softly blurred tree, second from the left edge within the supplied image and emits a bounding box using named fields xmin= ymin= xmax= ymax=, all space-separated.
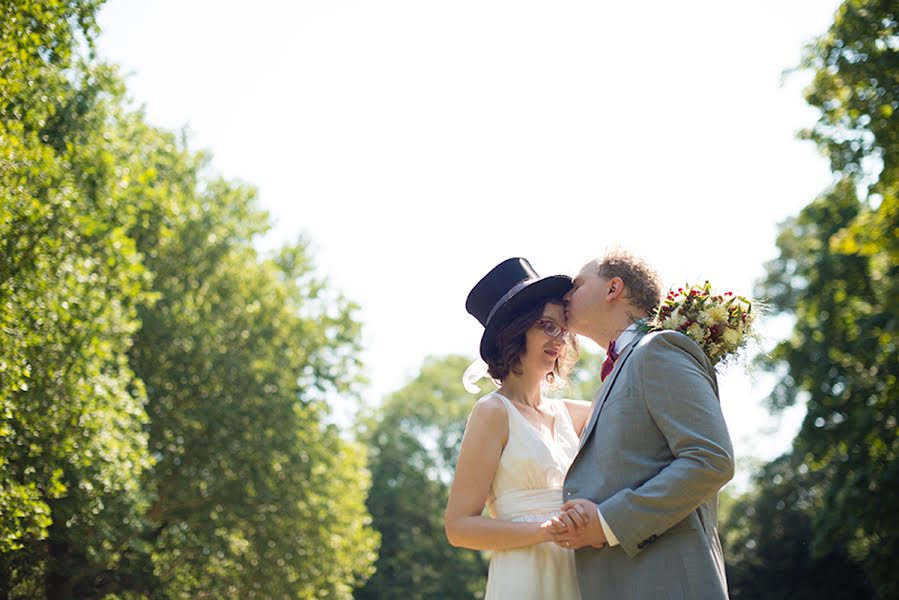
xmin=121 ymin=131 xmax=376 ymax=598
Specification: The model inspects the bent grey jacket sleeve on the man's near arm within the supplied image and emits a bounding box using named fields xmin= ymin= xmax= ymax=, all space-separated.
xmin=599 ymin=332 xmax=734 ymax=556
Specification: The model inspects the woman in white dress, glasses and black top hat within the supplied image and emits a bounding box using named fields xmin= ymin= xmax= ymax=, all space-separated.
xmin=445 ymin=258 xmax=590 ymax=600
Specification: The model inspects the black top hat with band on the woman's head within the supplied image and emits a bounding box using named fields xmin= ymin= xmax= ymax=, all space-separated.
xmin=465 ymin=258 xmax=572 ymax=360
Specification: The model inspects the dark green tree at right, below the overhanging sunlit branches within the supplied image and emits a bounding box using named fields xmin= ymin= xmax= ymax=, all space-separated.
xmin=763 ymin=180 xmax=899 ymax=597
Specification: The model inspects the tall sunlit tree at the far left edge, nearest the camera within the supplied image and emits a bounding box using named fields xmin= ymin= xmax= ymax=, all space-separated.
xmin=0 ymin=1 xmax=151 ymax=597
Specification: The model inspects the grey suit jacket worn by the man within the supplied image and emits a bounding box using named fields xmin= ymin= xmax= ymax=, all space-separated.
xmin=564 ymin=331 xmax=734 ymax=600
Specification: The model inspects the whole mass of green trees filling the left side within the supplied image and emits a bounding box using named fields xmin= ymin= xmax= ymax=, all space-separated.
xmin=0 ymin=0 xmax=377 ymax=599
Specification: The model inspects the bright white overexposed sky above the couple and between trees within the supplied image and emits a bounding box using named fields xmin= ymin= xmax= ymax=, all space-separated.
xmin=98 ymin=0 xmax=839 ymax=482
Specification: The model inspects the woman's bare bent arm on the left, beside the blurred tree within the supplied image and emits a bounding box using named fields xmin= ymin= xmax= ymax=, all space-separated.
xmin=444 ymin=397 xmax=551 ymax=550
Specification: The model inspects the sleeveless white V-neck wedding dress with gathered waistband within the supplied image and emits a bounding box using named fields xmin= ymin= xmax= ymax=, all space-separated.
xmin=484 ymin=392 xmax=581 ymax=600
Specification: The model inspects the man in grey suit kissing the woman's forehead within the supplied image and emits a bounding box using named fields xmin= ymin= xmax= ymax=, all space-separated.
xmin=548 ymin=250 xmax=734 ymax=600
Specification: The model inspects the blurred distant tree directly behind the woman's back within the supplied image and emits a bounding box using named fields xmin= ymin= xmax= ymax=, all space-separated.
xmin=355 ymin=356 xmax=492 ymax=600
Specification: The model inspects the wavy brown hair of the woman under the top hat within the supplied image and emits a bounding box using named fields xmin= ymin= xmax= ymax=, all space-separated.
xmin=485 ymin=298 xmax=579 ymax=385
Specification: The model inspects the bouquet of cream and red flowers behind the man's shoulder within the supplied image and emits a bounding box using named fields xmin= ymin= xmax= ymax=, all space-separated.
xmin=647 ymin=281 xmax=756 ymax=365
